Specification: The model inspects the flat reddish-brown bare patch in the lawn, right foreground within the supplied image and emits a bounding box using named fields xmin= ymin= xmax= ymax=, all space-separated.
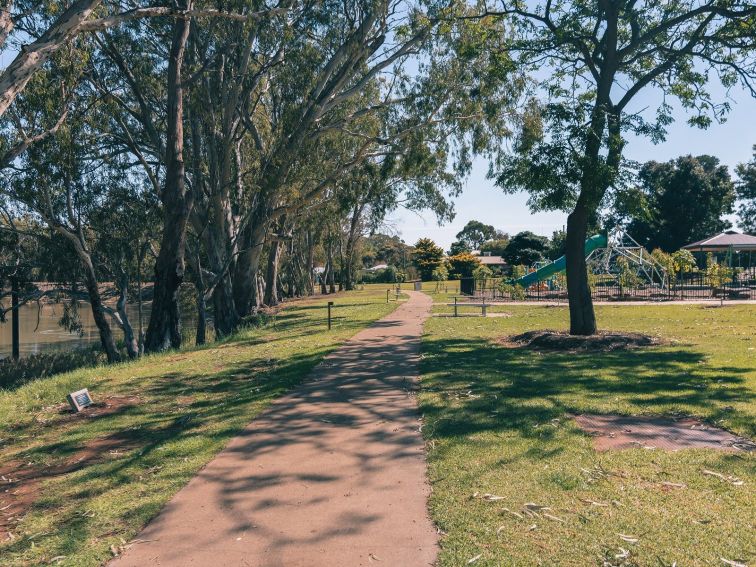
xmin=575 ymin=414 xmax=756 ymax=451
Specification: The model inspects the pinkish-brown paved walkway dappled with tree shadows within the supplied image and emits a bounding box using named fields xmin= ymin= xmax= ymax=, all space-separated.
xmin=111 ymin=292 xmax=437 ymax=567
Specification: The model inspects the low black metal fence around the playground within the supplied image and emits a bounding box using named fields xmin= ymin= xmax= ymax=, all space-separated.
xmin=460 ymin=267 xmax=756 ymax=301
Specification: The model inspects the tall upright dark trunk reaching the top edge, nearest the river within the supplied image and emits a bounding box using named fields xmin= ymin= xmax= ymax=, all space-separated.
xmin=145 ymin=1 xmax=193 ymax=352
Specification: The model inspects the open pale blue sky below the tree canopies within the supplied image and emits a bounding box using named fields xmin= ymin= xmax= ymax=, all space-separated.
xmin=387 ymin=83 xmax=756 ymax=249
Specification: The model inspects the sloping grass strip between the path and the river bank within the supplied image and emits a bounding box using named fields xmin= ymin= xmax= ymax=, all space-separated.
xmin=0 ymin=286 xmax=396 ymax=567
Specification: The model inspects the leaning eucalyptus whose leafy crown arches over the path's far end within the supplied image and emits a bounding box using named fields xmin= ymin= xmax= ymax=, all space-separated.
xmin=230 ymin=1 xmax=518 ymax=313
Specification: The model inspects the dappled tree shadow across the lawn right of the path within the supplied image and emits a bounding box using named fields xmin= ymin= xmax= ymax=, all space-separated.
xmin=421 ymin=338 xmax=754 ymax=446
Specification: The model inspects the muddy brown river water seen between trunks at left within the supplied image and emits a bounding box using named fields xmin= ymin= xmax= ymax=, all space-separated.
xmin=0 ymin=302 xmax=150 ymax=358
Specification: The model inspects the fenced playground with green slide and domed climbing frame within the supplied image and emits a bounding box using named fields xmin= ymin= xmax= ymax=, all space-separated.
xmin=461 ymin=229 xmax=756 ymax=301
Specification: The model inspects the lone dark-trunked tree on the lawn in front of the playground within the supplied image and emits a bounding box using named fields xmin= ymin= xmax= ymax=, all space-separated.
xmin=477 ymin=0 xmax=756 ymax=335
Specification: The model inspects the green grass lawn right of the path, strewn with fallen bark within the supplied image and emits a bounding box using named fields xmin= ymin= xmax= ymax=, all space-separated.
xmin=420 ymin=305 xmax=756 ymax=567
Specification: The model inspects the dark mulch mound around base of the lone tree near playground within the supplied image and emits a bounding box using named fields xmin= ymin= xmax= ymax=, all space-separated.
xmin=499 ymin=330 xmax=664 ymax=352
